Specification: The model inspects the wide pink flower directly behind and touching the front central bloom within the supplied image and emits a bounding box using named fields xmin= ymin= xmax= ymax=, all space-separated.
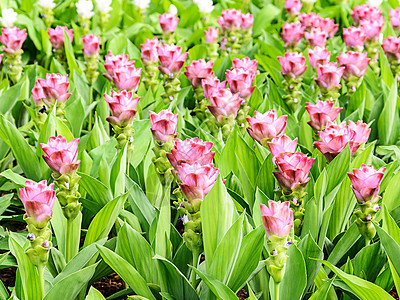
xmin=167 ymin=137 xmax=215 ymax=169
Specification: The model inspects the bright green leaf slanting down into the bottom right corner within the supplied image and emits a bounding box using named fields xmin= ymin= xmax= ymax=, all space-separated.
xmin=317 ymin=259 xmax=393 ymax=300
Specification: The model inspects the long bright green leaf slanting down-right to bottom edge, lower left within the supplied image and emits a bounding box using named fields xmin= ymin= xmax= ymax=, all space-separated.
xmin=97 ymin=246 xmax=156 ymax=300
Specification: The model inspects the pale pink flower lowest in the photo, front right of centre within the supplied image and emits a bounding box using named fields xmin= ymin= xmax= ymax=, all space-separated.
xmin=260 ymin=200 xmax=294 ymax=239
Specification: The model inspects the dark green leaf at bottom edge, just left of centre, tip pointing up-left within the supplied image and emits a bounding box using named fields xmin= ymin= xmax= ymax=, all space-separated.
xmin=154 ymin=255 xmax=199 ymax=300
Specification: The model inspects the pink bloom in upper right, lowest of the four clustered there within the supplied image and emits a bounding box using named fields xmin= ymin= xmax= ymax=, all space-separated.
xmin=315 ymin=62 xmax=344 ymax=91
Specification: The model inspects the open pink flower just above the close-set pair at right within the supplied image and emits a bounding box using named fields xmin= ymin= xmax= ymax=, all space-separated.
xmin=306 ymin=100 xmax=343 ymax=130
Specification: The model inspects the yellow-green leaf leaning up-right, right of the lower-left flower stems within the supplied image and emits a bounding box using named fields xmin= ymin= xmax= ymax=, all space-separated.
xmin=83 ymin=192 xmax=129 ymax=248
